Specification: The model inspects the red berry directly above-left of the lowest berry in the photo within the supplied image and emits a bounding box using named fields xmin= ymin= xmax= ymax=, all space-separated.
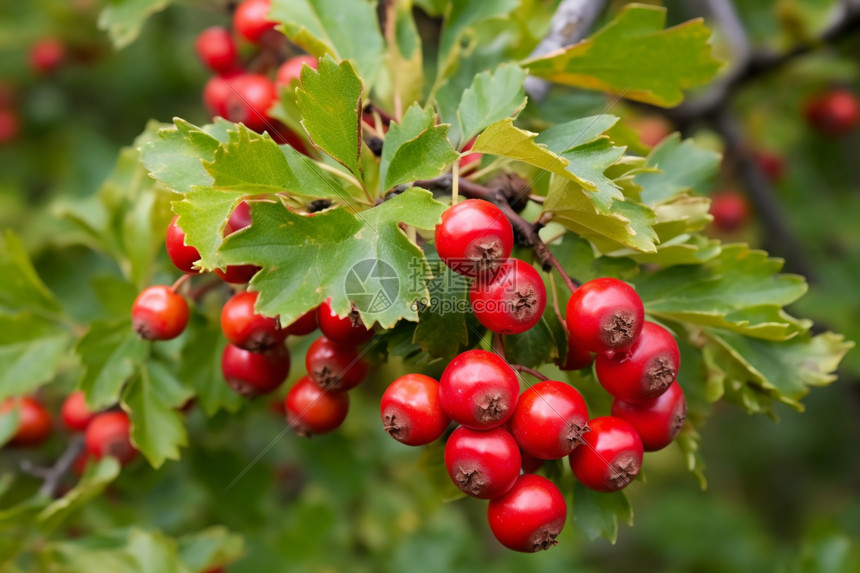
xmin=445 ymin=426 xmax=522 ymax=499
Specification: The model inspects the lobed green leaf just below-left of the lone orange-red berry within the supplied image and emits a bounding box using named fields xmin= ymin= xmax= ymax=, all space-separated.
xmin=75 ymin=319 xmax=150 ymax=410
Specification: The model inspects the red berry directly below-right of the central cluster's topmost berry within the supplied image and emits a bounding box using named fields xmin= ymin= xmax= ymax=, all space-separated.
xmin=469 ymin=259 xmax=546 ymax=334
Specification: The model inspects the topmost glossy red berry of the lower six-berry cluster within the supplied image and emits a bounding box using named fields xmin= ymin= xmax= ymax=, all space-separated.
xmin=439 ymin=350 xmax=520 ymax=430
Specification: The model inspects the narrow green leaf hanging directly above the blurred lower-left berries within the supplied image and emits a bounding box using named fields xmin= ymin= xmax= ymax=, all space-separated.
xmin=123 ymin=360 xmax=191 ymax=468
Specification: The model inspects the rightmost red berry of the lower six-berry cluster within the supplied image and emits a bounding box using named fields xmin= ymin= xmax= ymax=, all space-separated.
xmin=569 ymin=416 xmax=643 ymax=491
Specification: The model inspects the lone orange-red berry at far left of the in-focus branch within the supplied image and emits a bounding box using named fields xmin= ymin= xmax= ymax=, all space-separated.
xmin=131 ymin=285 xmax=188 ymax=340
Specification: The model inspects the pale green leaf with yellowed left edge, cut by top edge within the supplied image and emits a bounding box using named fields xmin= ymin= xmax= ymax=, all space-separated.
xmin=270 ymin=0 xmax=385 ymax=87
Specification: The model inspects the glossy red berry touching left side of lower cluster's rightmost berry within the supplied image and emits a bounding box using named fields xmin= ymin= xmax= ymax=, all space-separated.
xmin=510 ymin=380 xmax=588 ymax=460
